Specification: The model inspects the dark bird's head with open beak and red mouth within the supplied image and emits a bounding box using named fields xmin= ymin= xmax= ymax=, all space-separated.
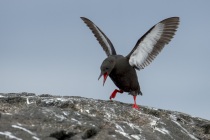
xmin=98 ymin=57 xmax=115 ymax=85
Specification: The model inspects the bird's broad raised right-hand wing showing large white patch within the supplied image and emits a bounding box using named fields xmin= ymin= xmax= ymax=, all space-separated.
xmin=126 ymin=17 xmax=179 ymax=69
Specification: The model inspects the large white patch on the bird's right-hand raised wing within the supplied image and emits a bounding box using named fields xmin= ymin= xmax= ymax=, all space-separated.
xmin=129 ymin=23 xmax=164 ymax=69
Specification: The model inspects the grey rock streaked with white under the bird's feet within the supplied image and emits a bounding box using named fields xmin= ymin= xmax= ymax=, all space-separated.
xmin=0 ymin=92 xmax=210 ymax=140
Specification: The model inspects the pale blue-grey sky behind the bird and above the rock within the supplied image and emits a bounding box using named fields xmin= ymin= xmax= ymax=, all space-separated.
xmin=0 ymin=0 xmax=210 ymax=120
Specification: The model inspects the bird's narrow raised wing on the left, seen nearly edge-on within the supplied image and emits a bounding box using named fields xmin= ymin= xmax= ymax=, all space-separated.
xmin=81 ymin=17 xmax=116 ymax=56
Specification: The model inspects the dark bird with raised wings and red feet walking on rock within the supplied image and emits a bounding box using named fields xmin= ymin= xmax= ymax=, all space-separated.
xmin=80 ymin=17 xmax=180 ymax=110
